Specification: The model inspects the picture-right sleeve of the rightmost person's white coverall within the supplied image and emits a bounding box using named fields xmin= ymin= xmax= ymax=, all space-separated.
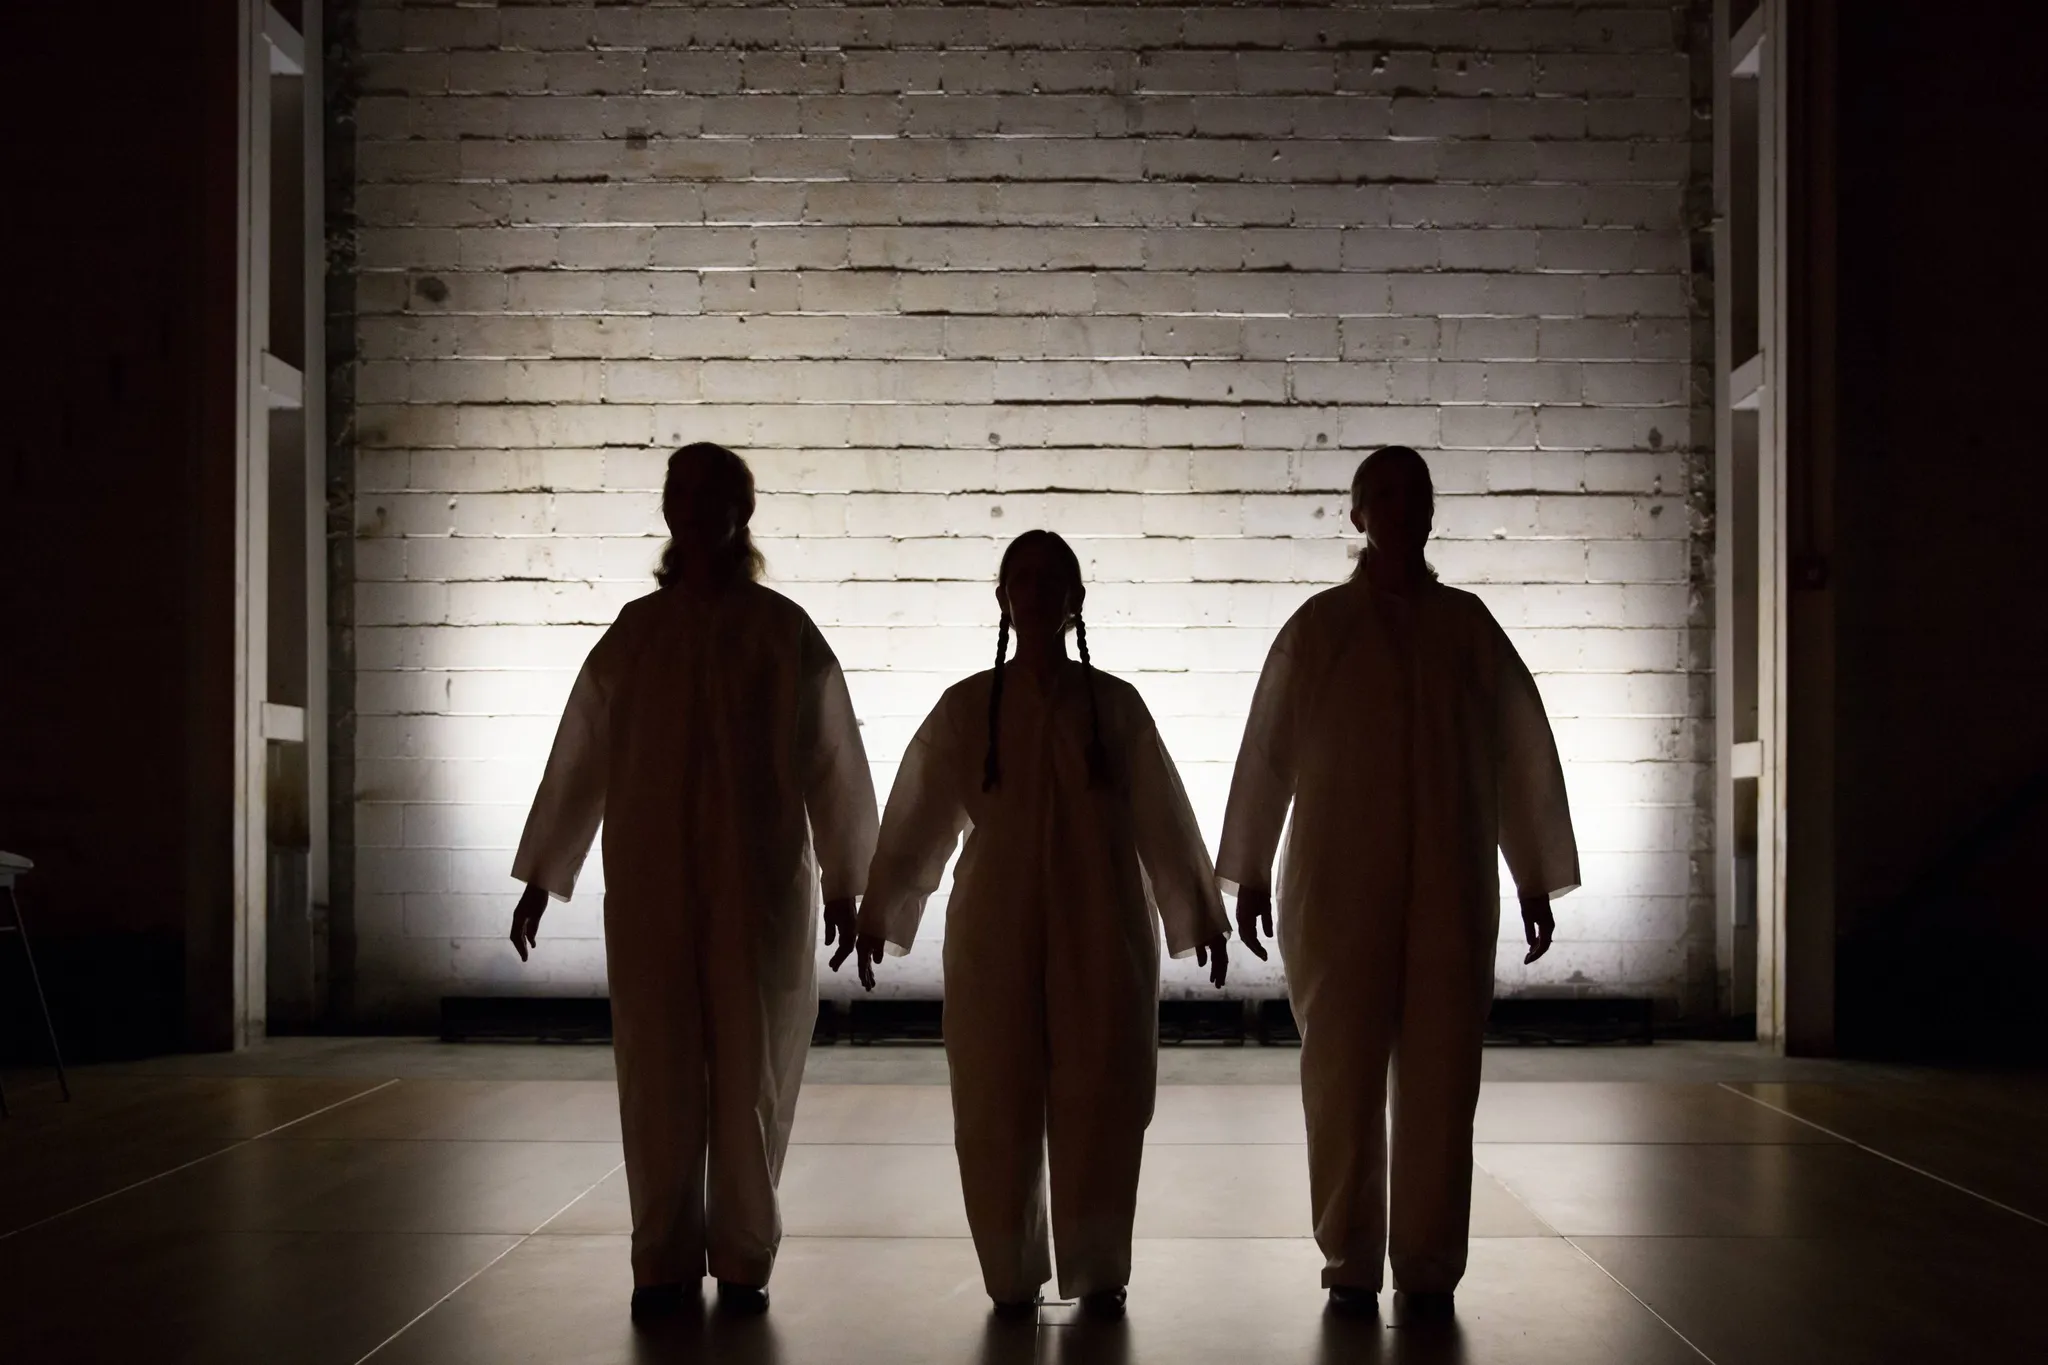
xmin=1493 ymin=622 xmax=1579 ymax=896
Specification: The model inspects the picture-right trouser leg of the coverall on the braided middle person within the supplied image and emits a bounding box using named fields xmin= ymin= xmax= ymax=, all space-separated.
xmin=1047 ymin=986 xmax=1157 ymax=1297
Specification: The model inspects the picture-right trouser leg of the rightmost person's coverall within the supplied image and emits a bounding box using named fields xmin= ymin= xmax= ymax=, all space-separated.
xmin=1389 ymin=927 xmax=1493 ymax=1293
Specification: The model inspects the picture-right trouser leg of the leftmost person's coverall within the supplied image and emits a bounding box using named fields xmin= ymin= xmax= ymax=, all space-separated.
xmin=698 ymin=896 xmax=817 ymax=1285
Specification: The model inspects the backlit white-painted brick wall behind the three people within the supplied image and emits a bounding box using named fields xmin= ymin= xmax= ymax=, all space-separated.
xmin=354 ymin=0 xmax=1712 ymax=1019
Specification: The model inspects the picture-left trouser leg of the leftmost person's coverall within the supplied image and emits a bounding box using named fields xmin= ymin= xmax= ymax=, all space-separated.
xmin=610 ymin=945 xmax=707 ymax=1285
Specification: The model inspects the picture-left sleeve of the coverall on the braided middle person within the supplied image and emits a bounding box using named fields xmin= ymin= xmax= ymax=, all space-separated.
xmin=860 ymin=698 xmax=967 ymax=956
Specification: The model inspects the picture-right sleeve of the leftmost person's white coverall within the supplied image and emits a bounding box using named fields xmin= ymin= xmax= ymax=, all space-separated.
xmin=801 ymin=626 xmax=877 ymax=900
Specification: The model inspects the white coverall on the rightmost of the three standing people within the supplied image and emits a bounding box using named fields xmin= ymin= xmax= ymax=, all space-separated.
xmin=1217 ymin=575 xmax=1579 ymax=1293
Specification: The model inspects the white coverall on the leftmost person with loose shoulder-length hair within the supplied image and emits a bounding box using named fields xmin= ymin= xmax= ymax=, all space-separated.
xmin=512 ymin=583 xmax=877 ymax=1285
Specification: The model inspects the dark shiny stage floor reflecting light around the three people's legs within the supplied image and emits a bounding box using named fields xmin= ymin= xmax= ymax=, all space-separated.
xmin=0 ymin=1040 xmax=2048 ymax=1365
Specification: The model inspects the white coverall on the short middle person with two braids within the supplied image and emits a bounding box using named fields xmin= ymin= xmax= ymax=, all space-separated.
xmin=860 ymin=663 xmax=1229 ymax=1304
